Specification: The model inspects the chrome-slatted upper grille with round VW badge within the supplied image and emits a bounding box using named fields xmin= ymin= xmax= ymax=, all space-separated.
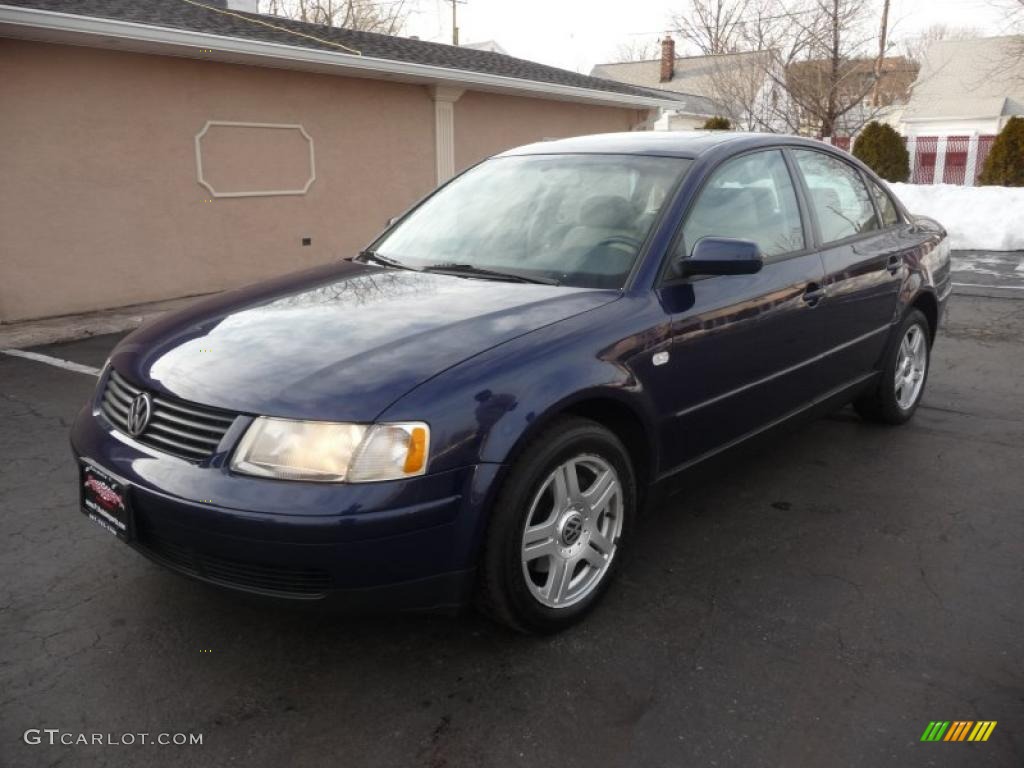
xmin=101 ymin=370 xmax=234 ymax=461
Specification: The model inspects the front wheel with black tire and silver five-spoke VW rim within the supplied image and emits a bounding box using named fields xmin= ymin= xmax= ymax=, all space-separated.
xmin=477 ymin=417 xmax=637 ymax=634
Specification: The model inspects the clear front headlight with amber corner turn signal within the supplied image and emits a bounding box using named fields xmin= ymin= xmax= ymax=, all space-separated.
xmin=231 ymin=416 xmax=430 ymax=482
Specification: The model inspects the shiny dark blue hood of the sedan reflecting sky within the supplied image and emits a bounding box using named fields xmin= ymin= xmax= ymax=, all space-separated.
xmin=112 ymin=262 xmax=620 ymax=421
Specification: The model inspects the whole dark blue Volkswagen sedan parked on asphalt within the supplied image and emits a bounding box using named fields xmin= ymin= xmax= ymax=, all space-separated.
xmin=72 ymin=132 xmax=950 ymax=632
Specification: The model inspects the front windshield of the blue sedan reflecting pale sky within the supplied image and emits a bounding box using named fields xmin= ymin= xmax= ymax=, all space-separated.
xmin=374 ymin=155 xmax=690 ymax=288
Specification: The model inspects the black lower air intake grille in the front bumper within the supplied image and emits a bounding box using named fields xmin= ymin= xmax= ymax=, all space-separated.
xmin=136 ymin=530 xmax=331 ymax=600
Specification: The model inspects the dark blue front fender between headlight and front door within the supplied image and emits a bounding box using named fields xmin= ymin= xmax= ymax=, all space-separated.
xmin=380 ymin=295 xmax=669 ymax=479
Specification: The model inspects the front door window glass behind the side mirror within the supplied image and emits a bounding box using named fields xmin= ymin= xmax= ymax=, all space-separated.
xmin=681 ymin=150 xmax=804 ymax=258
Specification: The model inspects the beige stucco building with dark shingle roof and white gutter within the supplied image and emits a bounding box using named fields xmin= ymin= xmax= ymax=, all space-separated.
xmin=0 ymin=0 xmax=673 ymax=323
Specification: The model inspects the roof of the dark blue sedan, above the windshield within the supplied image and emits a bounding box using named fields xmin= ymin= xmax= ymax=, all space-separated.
xmin=499 ymin=131 xmax=827 ymax=158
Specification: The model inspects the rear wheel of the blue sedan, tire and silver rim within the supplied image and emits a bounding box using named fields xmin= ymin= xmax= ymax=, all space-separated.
xmin=853 ymin=309 xmax=932 ymax=424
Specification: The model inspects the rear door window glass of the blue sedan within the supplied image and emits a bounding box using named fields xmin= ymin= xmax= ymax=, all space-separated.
xmin=793 ymin=150 xmax=880 ymax=245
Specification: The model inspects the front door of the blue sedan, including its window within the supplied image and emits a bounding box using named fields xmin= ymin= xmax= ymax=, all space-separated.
xmin=652 ymin=150 xmax=824 ymax=472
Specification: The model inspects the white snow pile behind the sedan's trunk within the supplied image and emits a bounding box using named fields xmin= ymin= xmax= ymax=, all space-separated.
xmin=889 ymin=183 xmax=1024 ymax=251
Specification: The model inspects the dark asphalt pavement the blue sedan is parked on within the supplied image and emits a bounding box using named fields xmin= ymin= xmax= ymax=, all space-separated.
xmin=0 ymin=264 xmax=1024 ymax=768
